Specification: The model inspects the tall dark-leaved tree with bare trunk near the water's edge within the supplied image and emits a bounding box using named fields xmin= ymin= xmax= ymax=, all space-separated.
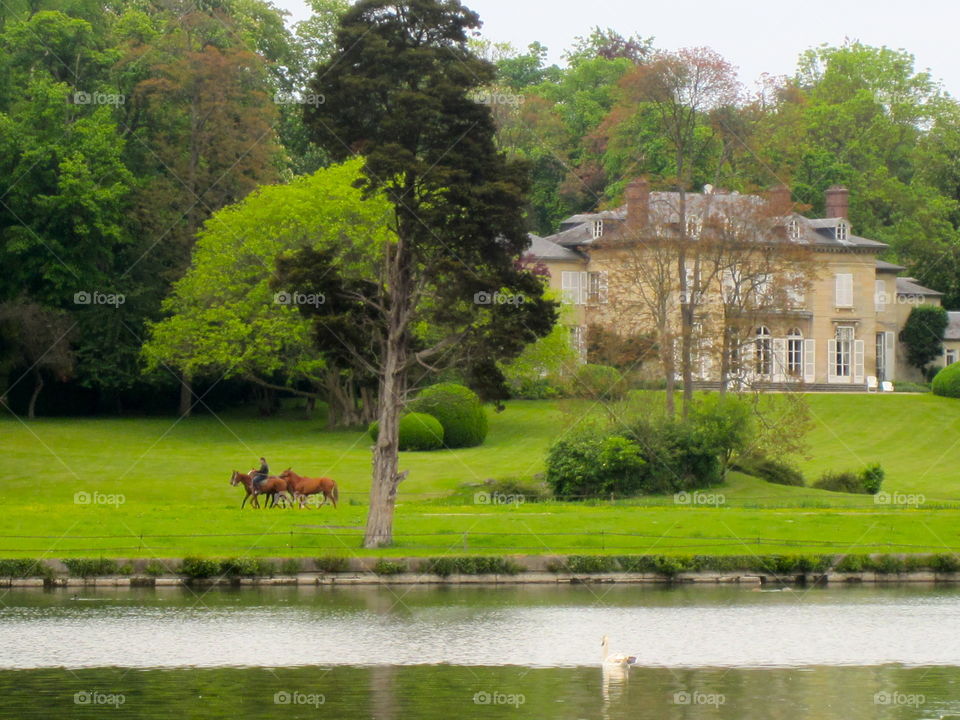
xmin=305 ymin=0 xmax=554 ymax=547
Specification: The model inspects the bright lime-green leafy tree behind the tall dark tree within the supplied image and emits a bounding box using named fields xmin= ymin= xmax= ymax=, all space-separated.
xmin=143 ymin=160 xmax=389 ymax=425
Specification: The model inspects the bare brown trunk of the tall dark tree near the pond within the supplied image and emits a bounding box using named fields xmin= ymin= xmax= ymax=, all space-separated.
xmin=363 ymin=239 xmax=411 ymax=548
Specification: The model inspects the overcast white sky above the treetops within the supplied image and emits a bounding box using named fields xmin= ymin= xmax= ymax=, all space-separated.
xmin=274 ymin=0 xmax=960 ymax=96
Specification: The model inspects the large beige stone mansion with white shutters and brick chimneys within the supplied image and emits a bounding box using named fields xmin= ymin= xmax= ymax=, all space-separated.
xmin=530 ymin=180 xmax=948 ymax=390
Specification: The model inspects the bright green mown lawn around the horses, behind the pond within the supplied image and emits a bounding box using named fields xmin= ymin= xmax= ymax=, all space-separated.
xmin=0 ymin=394 xmax=960 ymax=558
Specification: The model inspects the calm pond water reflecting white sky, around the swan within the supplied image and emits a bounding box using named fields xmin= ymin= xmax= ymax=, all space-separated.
xmin=0 ymin=585 xmax=960 ymax=720
